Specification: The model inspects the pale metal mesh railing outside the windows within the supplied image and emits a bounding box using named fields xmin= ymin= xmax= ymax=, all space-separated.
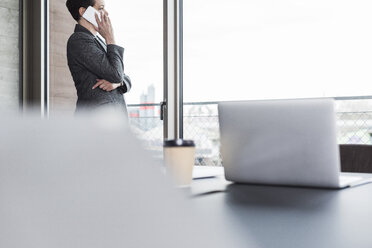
xmin=128 ymin=99 xmax=372 ymax=166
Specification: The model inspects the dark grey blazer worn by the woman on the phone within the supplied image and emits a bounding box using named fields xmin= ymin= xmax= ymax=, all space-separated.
xmin=67 ymin=24 xmax=131 ymax=112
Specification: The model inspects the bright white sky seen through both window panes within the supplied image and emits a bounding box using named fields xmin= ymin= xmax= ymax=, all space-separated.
xmin=106 ymin=0 xmax=372 ymax=103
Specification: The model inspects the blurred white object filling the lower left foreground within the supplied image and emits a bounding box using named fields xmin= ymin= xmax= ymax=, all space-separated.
xmin=0 ymin=113 xmax=247 ymax=248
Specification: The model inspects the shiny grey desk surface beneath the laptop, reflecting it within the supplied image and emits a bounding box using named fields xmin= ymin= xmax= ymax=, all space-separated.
xmin=190 ymin=170 xmax=372 ymax=248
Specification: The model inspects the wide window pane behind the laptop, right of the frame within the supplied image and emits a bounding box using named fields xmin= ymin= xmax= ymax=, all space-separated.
xmin=184 ymin=0 xmax=372 ymax=165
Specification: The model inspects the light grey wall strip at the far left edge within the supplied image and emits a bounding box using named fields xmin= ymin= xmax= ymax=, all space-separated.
xmin=0 ymin=0 xmax=19 ymax=110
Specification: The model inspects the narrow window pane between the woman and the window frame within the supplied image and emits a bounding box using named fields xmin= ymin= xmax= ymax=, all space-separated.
xmin=106 ymin=0 xmax=163 ymax=157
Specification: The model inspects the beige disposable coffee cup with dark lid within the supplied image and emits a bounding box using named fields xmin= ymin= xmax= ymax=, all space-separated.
xmin=164 ymin=139 xmax=195 ymax=186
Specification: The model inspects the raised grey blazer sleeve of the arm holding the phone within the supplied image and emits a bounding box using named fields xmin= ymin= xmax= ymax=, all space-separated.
xmin=68 ymin=35 xmax=124 ymax=83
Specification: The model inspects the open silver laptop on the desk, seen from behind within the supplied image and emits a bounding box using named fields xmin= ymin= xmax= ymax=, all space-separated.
xmin=218 ymin=98 xmax=371 ymax=188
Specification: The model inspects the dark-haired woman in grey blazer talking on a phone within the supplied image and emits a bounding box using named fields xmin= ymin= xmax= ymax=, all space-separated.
xmin=66 ymin=0 xmax=131 ymax=113
